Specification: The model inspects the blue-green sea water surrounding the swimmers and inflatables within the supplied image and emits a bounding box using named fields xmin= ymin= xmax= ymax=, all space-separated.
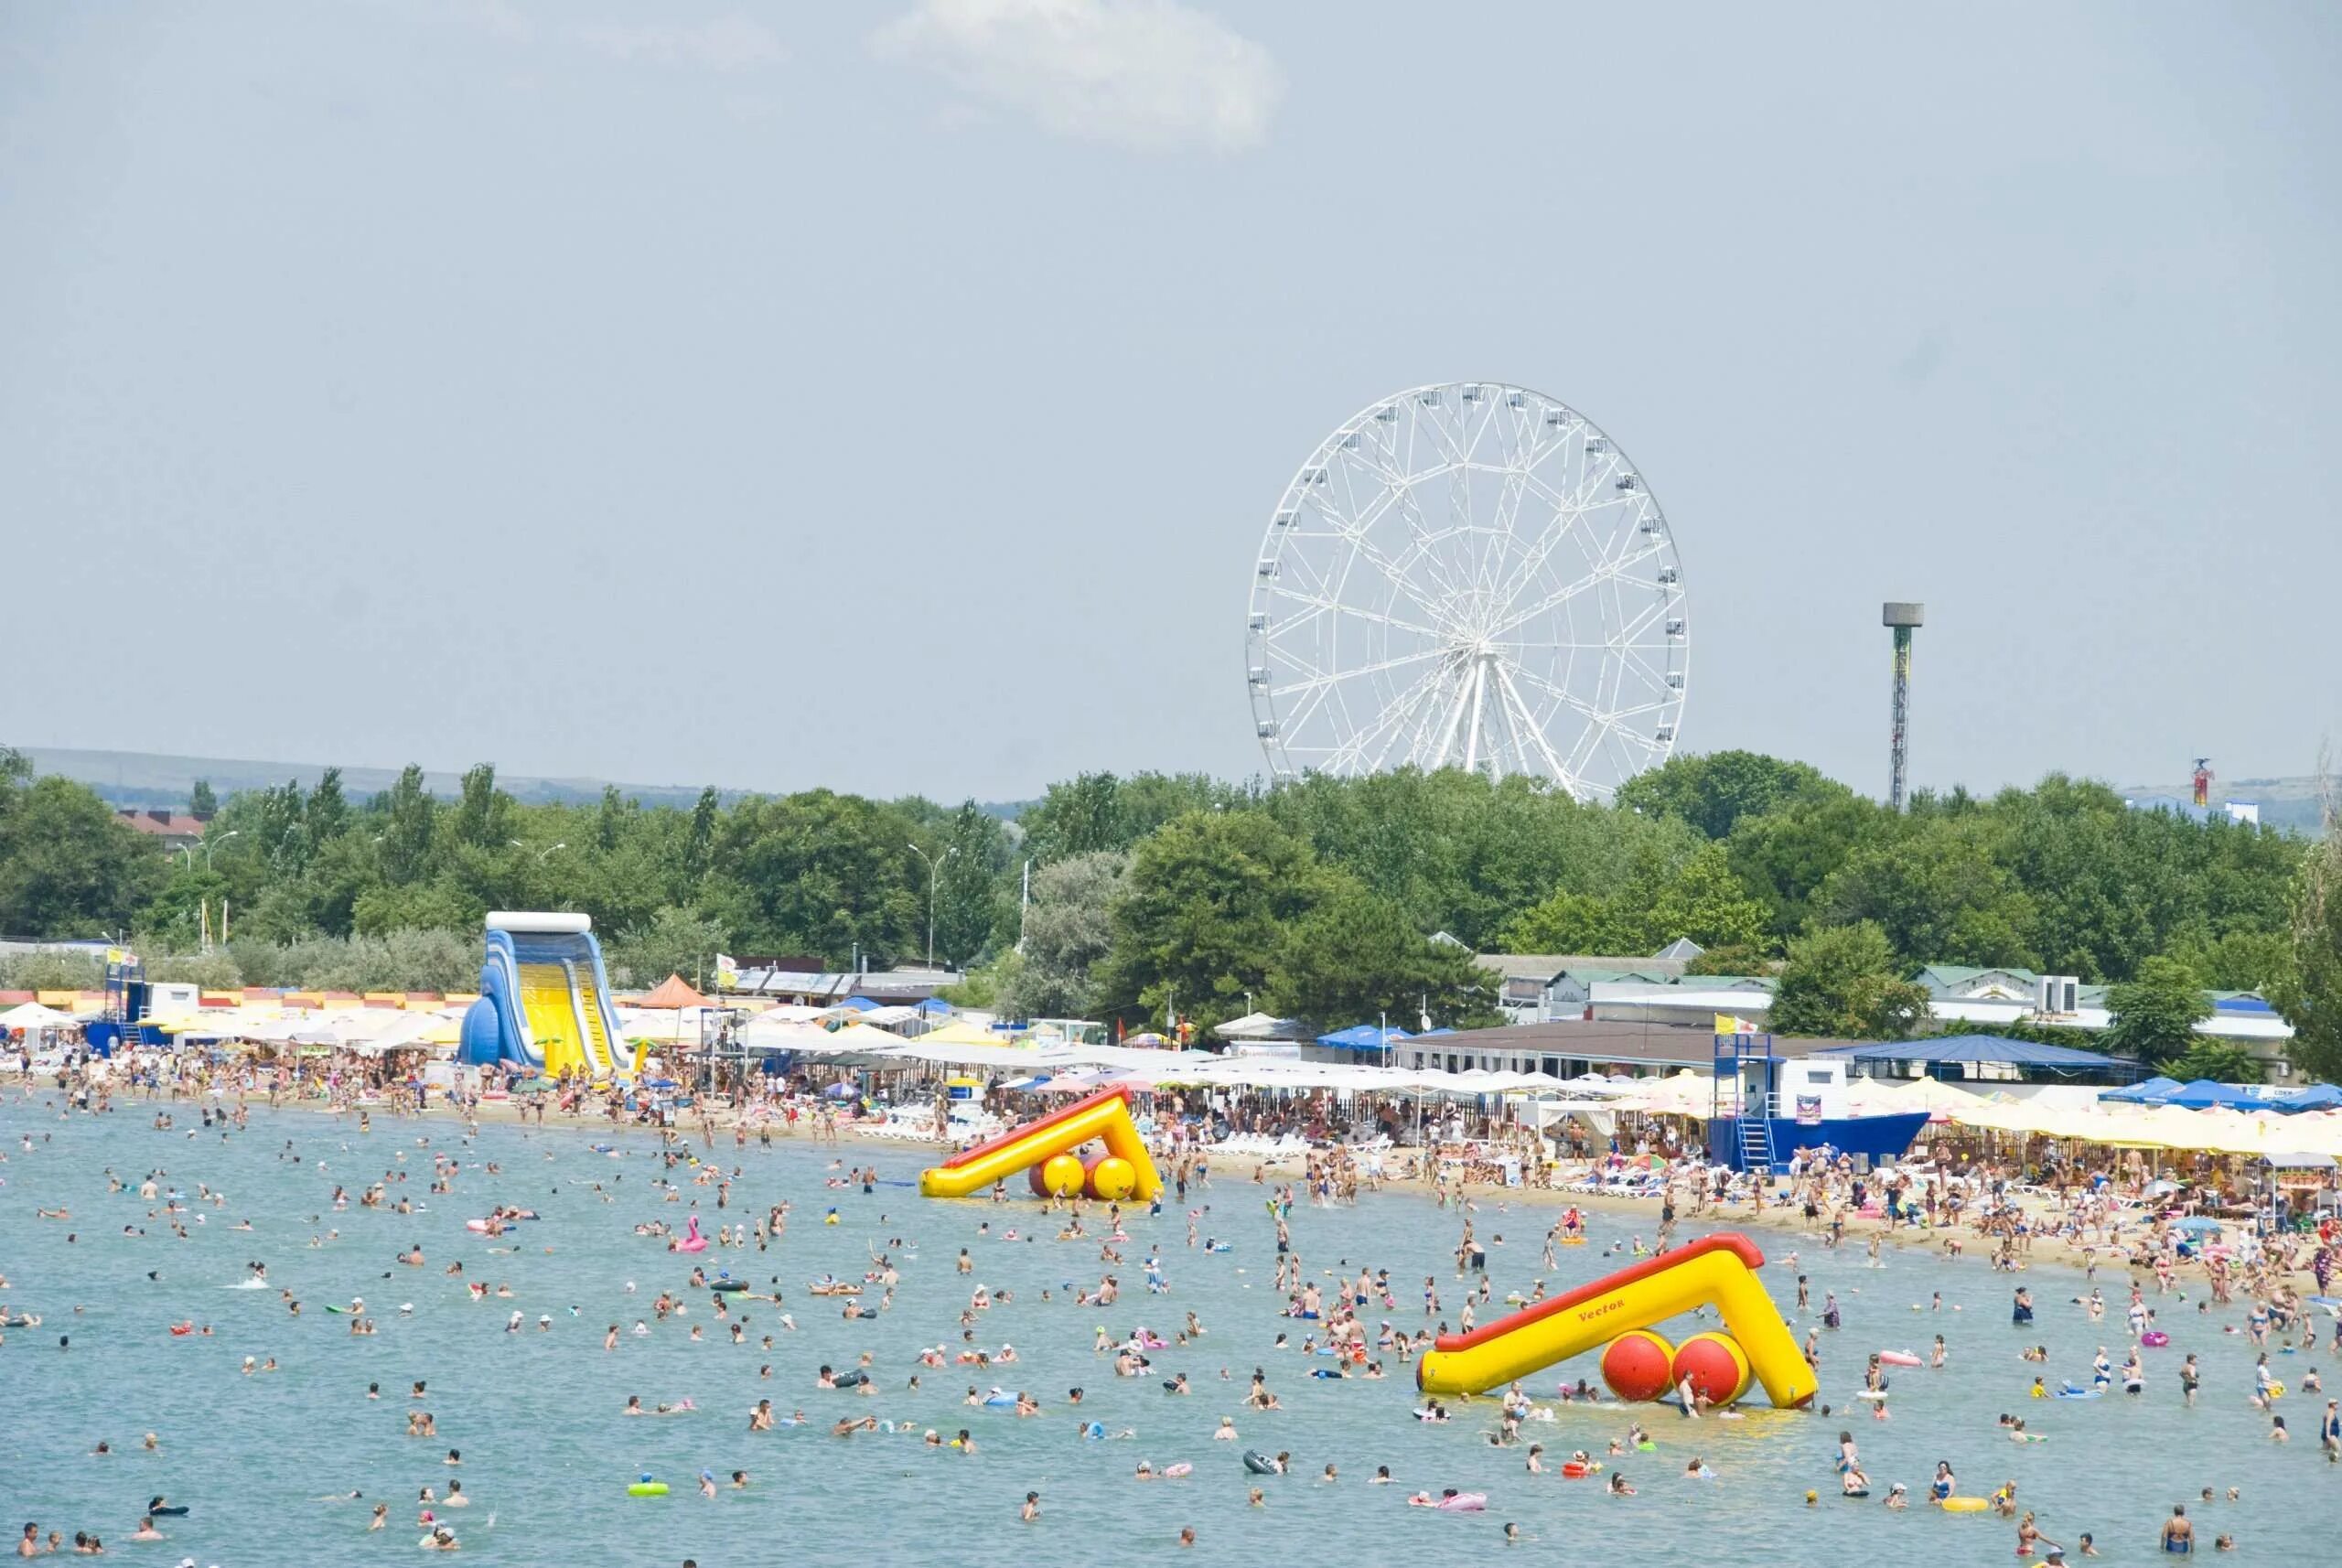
xmin=0 ymin=1102 xmax=2342 ymax=1568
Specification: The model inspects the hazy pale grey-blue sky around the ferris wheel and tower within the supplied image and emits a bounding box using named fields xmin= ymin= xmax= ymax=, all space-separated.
xmin=0 ymin=0 xmax=2342 ymax=798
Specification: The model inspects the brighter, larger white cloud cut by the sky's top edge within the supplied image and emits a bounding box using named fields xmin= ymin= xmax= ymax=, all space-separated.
xmin=871 ymin=0 xmax=1285 ymax=152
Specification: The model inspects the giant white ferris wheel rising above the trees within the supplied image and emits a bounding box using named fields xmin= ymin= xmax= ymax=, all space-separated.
xmin=1243 ymin=381 xmax=1691 ymax=800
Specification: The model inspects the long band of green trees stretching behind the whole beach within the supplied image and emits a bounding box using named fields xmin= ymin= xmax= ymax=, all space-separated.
xmin=0 ymin=751 xmax=2342 ymax=1072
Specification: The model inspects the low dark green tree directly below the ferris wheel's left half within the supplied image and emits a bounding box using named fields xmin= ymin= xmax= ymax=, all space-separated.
xmin=1267 ymin=873 xmax=1499 ymax=1030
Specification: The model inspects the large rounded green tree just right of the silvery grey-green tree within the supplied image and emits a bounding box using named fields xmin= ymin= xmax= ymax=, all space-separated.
xmin=1094 ymin=812 xmax=1321 ymax=1030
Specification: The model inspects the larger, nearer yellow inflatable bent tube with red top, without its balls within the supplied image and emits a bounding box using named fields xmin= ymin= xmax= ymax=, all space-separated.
xmin=1414 ymin=1233 xmax=1818 ymax=1409
